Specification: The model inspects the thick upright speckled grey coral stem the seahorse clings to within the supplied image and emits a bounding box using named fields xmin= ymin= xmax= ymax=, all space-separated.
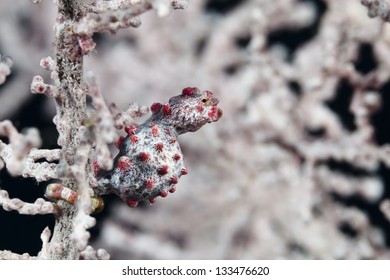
xmin=48 ymin=0 xmax=86 ymax=259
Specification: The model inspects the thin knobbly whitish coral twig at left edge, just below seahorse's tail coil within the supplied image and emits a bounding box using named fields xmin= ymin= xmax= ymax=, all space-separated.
xmin=0 ymin=190 xmax=56 ymax=215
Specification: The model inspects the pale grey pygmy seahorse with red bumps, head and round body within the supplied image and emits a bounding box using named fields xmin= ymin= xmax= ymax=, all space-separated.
xmin=96 ymin=88 xmax=222 ymax=207
